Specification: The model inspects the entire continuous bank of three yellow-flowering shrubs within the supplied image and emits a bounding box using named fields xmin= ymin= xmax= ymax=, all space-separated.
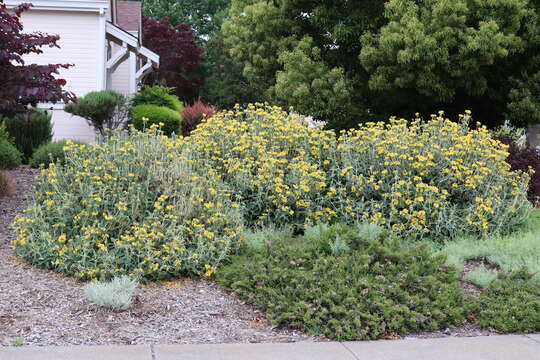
xmin=14 ymin=104 xmax=531 ymax=279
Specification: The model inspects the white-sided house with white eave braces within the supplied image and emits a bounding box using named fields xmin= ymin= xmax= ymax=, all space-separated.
xmin=4 ymin=0 xmax=159 ymax=142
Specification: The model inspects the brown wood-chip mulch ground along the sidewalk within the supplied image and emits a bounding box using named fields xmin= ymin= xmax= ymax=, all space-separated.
xmin=0 ymin=167 xmax=492 ymax=346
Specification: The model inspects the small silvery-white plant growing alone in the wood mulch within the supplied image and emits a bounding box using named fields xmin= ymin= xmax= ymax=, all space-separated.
xmin=84 ymin=276 xmax=138 ymax=311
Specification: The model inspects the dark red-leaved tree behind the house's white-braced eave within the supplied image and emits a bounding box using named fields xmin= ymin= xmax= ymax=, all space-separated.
xmin=143 ymin=17 xmax=204 ymax=102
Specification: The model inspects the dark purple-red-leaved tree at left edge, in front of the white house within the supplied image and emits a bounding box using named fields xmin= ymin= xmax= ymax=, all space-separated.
xmin=0 ymin=0 xmax=75 ymax=115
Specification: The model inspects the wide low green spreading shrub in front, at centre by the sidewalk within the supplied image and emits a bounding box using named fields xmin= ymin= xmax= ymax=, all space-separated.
xmin=216 ymin=225 xmax=464 ymax=340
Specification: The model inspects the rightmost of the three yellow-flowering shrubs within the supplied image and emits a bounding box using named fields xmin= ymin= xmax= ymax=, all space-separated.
xmin=336 ymin=112 xmax=531 ymax=237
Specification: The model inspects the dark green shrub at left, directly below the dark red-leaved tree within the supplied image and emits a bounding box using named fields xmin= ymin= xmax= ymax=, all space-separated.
xmin=3 ymin=109 xmax=52 ymax=162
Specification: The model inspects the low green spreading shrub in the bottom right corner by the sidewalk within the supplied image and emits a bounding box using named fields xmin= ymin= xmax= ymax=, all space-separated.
xmin=469 ymin=269 xmax=540 ymax=333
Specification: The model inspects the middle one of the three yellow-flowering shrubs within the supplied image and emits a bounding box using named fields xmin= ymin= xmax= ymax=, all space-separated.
xmin=185 ymin=104 xmax=336 ymax=227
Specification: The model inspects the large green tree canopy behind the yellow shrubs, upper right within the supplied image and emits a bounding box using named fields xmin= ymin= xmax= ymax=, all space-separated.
xmin=222 ymin=0 xmax=540 ymax=128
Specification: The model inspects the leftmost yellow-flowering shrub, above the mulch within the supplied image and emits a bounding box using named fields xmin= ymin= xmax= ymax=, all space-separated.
xmin=14 ymin=130 xmax=241 ymax=280
